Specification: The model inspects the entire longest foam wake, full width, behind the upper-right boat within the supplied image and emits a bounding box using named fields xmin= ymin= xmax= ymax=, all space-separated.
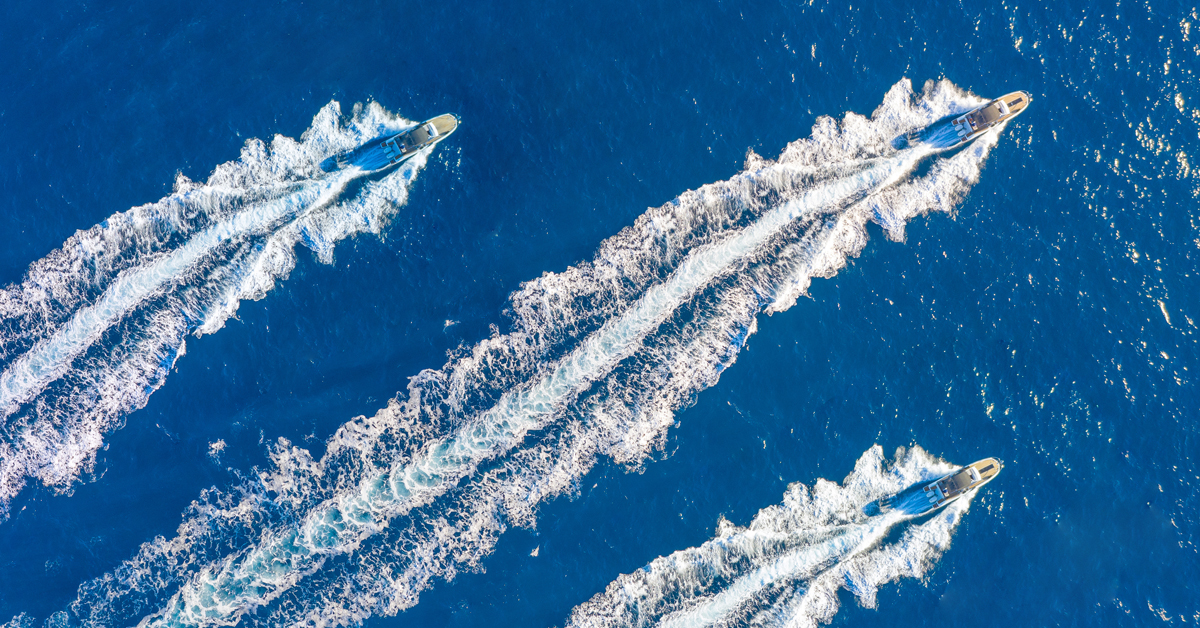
xmin=39 ymin=82 xmax=995 ymax=626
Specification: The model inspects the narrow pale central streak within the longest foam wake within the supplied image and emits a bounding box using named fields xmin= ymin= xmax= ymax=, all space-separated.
xmin=148 ymin=142 xmax=928 ymax=626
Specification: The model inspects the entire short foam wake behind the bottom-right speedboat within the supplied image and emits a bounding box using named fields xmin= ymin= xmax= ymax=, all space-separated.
xmin=568 ymin=445 xmax=970 ymax=628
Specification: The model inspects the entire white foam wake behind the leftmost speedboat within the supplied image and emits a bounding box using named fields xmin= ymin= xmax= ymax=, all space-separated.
xmin=0 ymin=102 xmax=426 ymax=516
